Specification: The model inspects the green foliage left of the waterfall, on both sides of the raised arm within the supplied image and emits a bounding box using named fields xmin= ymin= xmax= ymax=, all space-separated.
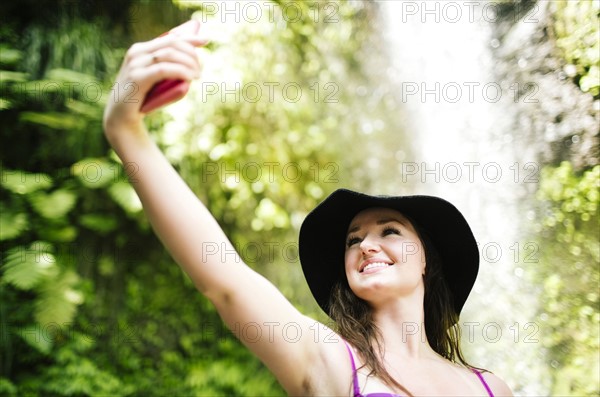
xmin=0 ymin=2 xmax=386 ymax=396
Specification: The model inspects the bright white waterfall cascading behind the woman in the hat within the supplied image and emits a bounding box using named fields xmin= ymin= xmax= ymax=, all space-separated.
xmin=378 ymin=1 xmax=548 ymax=395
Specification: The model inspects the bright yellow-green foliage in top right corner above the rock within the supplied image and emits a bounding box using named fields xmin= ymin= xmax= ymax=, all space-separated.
xmin=551 ymin=0 xmax=600 ymax=97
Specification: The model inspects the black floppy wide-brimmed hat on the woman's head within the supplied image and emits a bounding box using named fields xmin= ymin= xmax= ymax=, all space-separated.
xmin=299 ymin=189 xmax=479 ymax=314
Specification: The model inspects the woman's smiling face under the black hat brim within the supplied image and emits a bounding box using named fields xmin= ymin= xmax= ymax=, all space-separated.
xmin=345 ymin=208 xmax=425 ymax=303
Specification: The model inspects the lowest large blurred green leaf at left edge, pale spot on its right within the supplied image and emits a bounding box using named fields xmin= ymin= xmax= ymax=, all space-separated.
xmin=2 ymin=242 xmax=57 ymax=290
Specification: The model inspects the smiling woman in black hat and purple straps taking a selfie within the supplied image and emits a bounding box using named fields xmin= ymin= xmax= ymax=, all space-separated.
xmin=104 ymin=25 xmax=511 ymax=396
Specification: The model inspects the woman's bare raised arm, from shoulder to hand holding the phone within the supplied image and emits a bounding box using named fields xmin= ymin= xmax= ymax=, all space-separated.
xmin=104 ymin=27 xmax=350 ymax=394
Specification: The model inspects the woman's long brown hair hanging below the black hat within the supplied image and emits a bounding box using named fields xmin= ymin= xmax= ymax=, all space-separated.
xmin=329 ymin=219 xmax=476 ymax=396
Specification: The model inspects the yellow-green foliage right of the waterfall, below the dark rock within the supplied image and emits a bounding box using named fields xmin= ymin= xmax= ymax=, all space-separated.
xmin=532 ymin=162 xmax=600 ymax=396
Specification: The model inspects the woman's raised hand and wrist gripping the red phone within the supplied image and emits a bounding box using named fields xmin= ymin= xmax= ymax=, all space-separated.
xmin=104 ymin=28 xmax=207 ymax=144
